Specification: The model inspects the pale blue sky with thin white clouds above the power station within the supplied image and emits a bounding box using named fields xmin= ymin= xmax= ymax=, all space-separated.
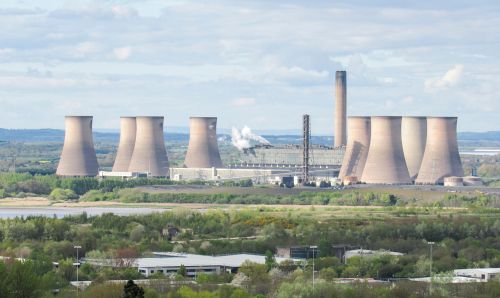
xmin=0 ymin=0 xmax=500 ymax=134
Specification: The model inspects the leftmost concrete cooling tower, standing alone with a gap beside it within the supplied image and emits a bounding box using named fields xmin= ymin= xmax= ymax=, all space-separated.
xmin=56 ymin=116 xmax=99 ymax=176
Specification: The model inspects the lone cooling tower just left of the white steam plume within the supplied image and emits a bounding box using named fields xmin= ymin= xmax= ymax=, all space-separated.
xmin=184 ymin=117 xmax=223 ymax=168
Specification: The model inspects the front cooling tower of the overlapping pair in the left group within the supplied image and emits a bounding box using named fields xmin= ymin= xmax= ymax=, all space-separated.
xmin=128 ymin=117 xmax=168 ymax=177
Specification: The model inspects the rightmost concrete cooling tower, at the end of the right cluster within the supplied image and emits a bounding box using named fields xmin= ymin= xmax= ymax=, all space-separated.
xmin=415 ymin=117 xmax=464 ymax=184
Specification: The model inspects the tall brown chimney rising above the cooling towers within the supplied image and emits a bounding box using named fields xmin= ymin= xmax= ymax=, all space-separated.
xmin=335 ymin=71 xmax=347 ymax=147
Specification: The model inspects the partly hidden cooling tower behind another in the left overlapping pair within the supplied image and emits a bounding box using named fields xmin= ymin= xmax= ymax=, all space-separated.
xmin=113 ymin=117 xmax=136 ymax=172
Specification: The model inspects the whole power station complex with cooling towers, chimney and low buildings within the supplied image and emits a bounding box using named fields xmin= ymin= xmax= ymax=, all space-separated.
xmin=57 ymin=71 xmax=468 ymax=186
